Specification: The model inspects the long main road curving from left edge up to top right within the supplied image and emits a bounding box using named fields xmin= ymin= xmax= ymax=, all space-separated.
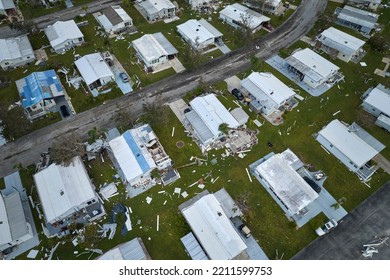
xmin=0 ymin=0 xmax=327 ymax=178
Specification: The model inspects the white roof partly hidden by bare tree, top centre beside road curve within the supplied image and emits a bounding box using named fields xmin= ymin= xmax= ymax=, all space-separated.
xmin=219 ymin=3 xmax=270 ymax=29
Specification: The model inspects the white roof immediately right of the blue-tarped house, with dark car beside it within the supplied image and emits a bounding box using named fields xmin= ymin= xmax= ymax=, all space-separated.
xmin=75 ymin=53 xmax=114 ymax=85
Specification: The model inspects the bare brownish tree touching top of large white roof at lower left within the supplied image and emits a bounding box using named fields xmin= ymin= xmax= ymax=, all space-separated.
xmin=50 ymin=133 xmax=86 ymax=166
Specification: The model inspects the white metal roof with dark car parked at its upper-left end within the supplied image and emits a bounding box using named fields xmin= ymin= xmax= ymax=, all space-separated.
xmin=241 ymin=72 xmax=295 ymax=107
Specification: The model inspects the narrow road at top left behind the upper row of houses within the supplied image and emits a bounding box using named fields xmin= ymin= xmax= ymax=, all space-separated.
xmin=0 ymin=0 xmax=122 ymax=39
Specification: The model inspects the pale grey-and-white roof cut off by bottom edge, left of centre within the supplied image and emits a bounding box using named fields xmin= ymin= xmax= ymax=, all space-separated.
xmin=97 ymin=237 xmax=150 ymax=260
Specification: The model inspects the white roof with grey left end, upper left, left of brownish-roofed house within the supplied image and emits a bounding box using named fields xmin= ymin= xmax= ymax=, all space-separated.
xmin=45 ymin=20 xmax=84 ymax=48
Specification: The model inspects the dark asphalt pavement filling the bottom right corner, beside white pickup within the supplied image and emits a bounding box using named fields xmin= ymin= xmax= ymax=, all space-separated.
xmin=293 ymin=182 xmax=390 ymax=260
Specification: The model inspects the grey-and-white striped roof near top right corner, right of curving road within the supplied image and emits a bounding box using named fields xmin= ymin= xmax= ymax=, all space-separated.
xmin=337 ymin=5 xmax=379 ymax=29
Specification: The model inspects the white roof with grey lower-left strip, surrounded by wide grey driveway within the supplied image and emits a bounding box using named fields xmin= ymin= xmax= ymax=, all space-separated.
xmin=286 ymin=48 xmax=340 ymax=81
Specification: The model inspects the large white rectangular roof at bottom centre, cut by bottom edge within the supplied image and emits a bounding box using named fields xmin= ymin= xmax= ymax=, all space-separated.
xmin=182 ymin=194 xmax=247 ymax=260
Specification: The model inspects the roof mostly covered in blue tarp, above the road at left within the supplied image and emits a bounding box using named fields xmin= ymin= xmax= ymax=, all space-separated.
xmin=17 ymin=70 xmax=63 ymax=108
